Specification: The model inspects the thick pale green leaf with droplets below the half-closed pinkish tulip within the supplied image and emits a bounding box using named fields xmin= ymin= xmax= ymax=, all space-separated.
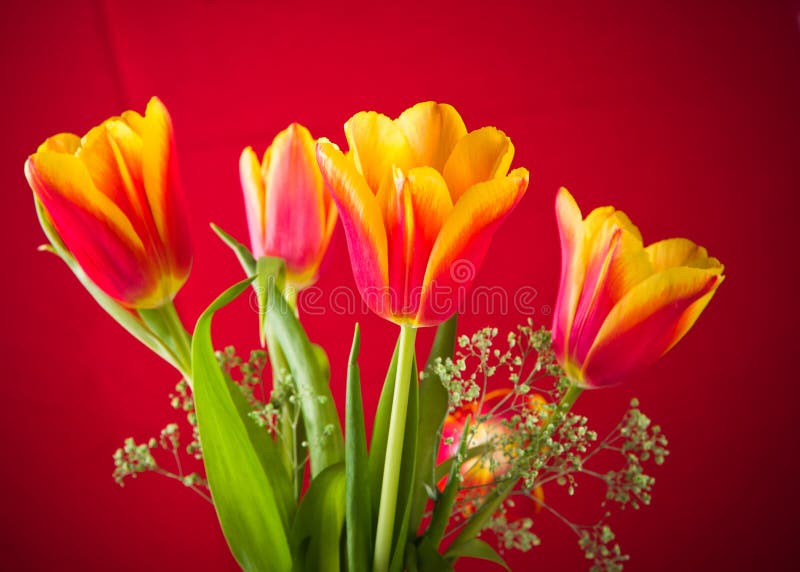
xmin=264 ymin=274 xmax=344 ymax=477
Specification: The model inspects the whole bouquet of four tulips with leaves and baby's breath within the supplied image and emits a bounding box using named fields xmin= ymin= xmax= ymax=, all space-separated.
xmin=25 ymin=98 xmax=723 ymax=572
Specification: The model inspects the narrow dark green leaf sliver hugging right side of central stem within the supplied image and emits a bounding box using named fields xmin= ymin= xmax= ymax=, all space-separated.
xmin=389 ymin=360 xmax=419 ymax=572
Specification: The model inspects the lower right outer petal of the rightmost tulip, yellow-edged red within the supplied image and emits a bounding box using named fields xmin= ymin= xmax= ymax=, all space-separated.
xmin=582 ymin=267 xmax=723 ymax=387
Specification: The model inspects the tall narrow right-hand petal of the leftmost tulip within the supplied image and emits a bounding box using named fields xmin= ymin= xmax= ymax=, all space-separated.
xmin=140 ymin=97 xmax=192 ymax=284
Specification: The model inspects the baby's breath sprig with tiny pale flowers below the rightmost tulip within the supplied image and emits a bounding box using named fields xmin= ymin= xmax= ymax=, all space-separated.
xmin=432 ymin=320 xmax=669 ymax=571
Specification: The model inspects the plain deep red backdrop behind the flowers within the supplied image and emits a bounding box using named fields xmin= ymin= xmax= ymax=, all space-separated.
xmin=0 ymin=0 xmax=800 ymax=571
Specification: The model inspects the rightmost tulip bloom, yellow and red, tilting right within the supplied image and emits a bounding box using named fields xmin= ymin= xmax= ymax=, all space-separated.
xmin=553 ymin=189 xmax=724 ymax=388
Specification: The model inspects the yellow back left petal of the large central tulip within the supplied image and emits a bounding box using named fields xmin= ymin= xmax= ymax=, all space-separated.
xmin=344 ymin=111 xmax=414 ymax=194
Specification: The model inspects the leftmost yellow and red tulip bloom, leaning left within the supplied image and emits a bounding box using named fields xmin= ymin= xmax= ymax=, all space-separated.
xmin=25 ymin=97 xmax=192 ymax=309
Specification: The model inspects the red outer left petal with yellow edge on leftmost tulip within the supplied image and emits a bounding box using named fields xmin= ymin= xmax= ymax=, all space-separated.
xmin=25 ymin=151 xmax=164 ymax=307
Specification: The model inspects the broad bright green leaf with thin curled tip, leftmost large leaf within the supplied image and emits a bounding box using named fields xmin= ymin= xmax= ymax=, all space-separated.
xmin=192 ymin=279 xmax=292 ymax=572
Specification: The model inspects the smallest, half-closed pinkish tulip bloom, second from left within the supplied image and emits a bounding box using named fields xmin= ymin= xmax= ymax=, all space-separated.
xmin=239 ymin=123 xmax=336 ymax=289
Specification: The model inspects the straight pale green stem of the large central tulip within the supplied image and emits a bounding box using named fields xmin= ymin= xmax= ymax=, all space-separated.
xmin=373 ymin=325 xmax=417 ymax=572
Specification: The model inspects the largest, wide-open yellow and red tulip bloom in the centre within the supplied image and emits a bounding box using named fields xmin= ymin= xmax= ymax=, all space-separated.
xmin=317 ymin=102 xmax=528 ymax=326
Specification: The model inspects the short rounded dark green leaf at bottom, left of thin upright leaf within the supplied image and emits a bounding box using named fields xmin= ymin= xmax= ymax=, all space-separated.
xmin=290 ymin=463 xmax=346 ymax=572
